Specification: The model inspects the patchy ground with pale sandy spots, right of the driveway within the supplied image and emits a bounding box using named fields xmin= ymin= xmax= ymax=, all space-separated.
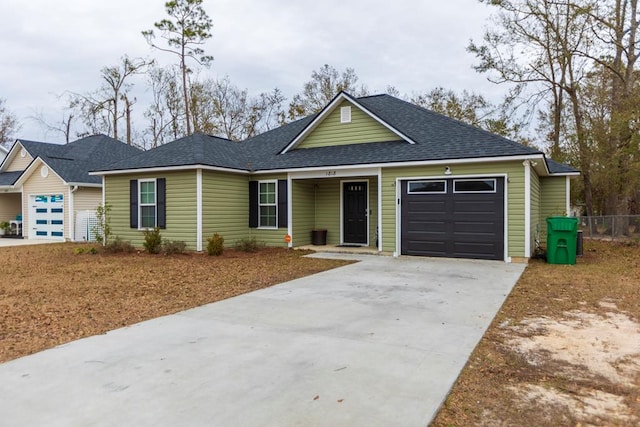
xmin=432 ymin=241 xmax=640 ymax=427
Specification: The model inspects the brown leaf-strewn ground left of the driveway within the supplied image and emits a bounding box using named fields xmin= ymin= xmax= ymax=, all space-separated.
xmin=0 ymin=243 xmax=348 ymax=362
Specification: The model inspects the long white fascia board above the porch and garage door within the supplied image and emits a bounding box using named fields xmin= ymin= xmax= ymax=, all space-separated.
xmin=252 ymin=154 xmax=544 ymax=177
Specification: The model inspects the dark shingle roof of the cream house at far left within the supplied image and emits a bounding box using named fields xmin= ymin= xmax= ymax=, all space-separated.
xmin=19 ymin=135 xmax=142 ymax=184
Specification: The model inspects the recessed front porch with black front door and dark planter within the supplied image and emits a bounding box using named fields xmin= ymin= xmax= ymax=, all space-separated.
xmin=290 ymin=171 xmax=379 ymax=249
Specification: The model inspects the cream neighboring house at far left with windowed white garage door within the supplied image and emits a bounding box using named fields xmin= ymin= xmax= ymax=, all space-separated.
xmin=0 ymin=135 xmax=141 ymax=241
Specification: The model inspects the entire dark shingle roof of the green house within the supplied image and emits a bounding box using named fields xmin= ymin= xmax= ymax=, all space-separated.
xmin=92 ymin=95 xmax=573 ymax=173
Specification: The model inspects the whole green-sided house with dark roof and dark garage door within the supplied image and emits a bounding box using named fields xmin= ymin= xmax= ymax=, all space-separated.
xmin=95 ymin=93 xmax=579 ymax=261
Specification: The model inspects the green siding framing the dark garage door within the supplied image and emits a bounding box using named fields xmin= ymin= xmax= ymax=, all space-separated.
xmin=381 ymin=161 xmax=525 ymax=257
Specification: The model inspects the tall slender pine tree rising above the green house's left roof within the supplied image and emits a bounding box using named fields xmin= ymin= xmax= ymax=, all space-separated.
xmin=142 ymin=0 xmax=213 ymax=135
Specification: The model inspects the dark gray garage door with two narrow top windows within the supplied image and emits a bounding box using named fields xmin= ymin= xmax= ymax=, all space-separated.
xmin=401 ymin=177 xmax=504 ymax=260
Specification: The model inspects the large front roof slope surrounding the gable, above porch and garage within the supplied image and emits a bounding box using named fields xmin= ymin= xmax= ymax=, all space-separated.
xmin=240 ymin=95 xmax=541 ymax=170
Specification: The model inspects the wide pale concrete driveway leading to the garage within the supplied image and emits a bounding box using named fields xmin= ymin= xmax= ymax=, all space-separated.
xmin=0 ymin=254 xmax=524 ymax=426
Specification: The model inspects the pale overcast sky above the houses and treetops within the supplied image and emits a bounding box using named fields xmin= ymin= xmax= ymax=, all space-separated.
xmin=0 ymin=0 xmax=504 ymax=142
